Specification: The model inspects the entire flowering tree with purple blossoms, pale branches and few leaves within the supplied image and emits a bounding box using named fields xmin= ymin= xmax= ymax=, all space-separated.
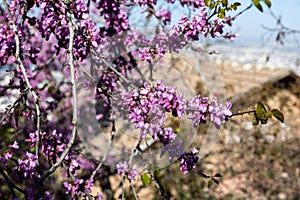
xmin=0 ymin=0 xmax=284 ymax=199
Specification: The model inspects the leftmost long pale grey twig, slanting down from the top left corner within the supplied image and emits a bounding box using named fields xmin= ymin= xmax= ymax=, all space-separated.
xmin=3 ymin=0 xmax=41 ymax=165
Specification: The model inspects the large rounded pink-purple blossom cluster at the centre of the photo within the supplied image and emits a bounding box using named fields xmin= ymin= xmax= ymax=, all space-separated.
xmin=127 ymin=81 xmax=185 ymax=139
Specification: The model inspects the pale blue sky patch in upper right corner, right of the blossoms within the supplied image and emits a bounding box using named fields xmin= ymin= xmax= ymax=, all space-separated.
xmin=232 ymin=0 xmax=300 ymax=43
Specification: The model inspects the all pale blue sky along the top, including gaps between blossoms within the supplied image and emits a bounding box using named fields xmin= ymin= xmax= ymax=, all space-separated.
xmin=131 ymin=0 xmax=300 ymax=44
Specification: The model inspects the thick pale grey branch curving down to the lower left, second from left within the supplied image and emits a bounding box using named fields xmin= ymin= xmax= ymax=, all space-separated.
xmin=39 ymin=11 xmax=78 ymax=184
